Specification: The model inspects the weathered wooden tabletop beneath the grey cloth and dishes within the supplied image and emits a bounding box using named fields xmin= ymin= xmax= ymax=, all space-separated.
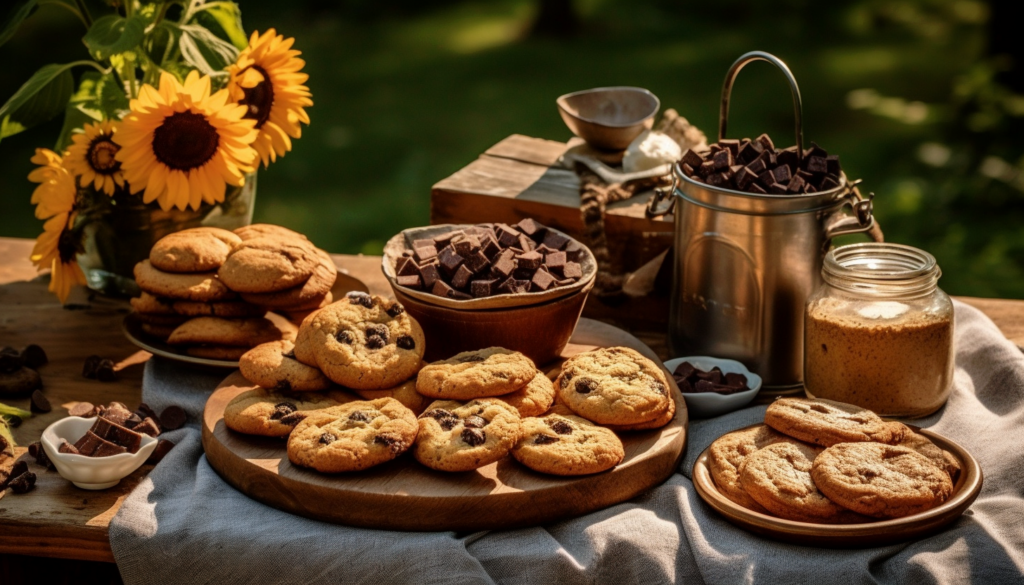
xmin=0 ymin=223 xmax=1024 ymax=561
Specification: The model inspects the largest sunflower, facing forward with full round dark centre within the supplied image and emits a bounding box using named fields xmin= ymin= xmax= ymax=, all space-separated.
xmin=114 ymin=71 xmax=258 ymax=211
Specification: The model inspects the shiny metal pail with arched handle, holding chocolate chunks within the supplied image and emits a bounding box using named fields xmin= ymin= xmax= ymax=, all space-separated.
xmin=648 ymin=51 xmax=881 ymax=394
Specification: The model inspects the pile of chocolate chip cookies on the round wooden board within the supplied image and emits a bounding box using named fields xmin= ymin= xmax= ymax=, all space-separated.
xmin=224 ymin=293 xmax=675 ymax=475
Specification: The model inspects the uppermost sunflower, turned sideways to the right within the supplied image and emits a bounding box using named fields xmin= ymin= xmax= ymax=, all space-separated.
xmin=227 ymin=29 xmax=313 ymax=167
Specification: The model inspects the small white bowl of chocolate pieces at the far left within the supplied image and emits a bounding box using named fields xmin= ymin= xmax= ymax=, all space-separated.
xmin=42 ymin=416 xmax=157 ymax=490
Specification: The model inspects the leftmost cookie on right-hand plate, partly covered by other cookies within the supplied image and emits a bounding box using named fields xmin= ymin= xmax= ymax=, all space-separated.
xmin=708 ymin=424 xmax=795 ymax=513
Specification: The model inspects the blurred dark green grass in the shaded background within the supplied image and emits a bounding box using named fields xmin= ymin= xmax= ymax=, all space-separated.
xmin=0 ymin=0 xmax=1024 ymax=297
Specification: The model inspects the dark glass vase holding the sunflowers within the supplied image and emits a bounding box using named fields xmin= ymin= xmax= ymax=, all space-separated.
xmin=75 ymin=172 xmax=256 ymax=296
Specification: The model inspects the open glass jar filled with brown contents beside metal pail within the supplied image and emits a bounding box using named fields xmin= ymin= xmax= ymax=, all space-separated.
xmin=804 ymin=243 xmax=953 ymax=417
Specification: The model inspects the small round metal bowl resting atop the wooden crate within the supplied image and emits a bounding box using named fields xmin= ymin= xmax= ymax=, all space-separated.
xmin=556 ymin=87 xmax=662 ymax=151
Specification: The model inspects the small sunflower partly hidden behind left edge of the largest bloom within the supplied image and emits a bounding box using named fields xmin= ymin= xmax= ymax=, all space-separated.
xmin=65 ymin=120 xmax=125 ymax=196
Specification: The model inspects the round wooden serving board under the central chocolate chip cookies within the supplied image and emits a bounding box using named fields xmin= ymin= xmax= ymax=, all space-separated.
xmin=203 ymin=319 xmax=687 ymax=531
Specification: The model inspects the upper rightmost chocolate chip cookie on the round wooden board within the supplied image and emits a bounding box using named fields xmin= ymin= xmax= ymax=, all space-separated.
xmin=555 ymin=347 xmax=672 ymax=425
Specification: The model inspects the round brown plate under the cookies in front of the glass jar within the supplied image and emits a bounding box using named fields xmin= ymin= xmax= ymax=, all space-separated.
xmin=693 ymin=424 xmax=982 ymax=548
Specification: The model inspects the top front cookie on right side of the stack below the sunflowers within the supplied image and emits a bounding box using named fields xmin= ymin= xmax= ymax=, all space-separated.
xmin=217 ymin=237 xmax=322 ymax=293
